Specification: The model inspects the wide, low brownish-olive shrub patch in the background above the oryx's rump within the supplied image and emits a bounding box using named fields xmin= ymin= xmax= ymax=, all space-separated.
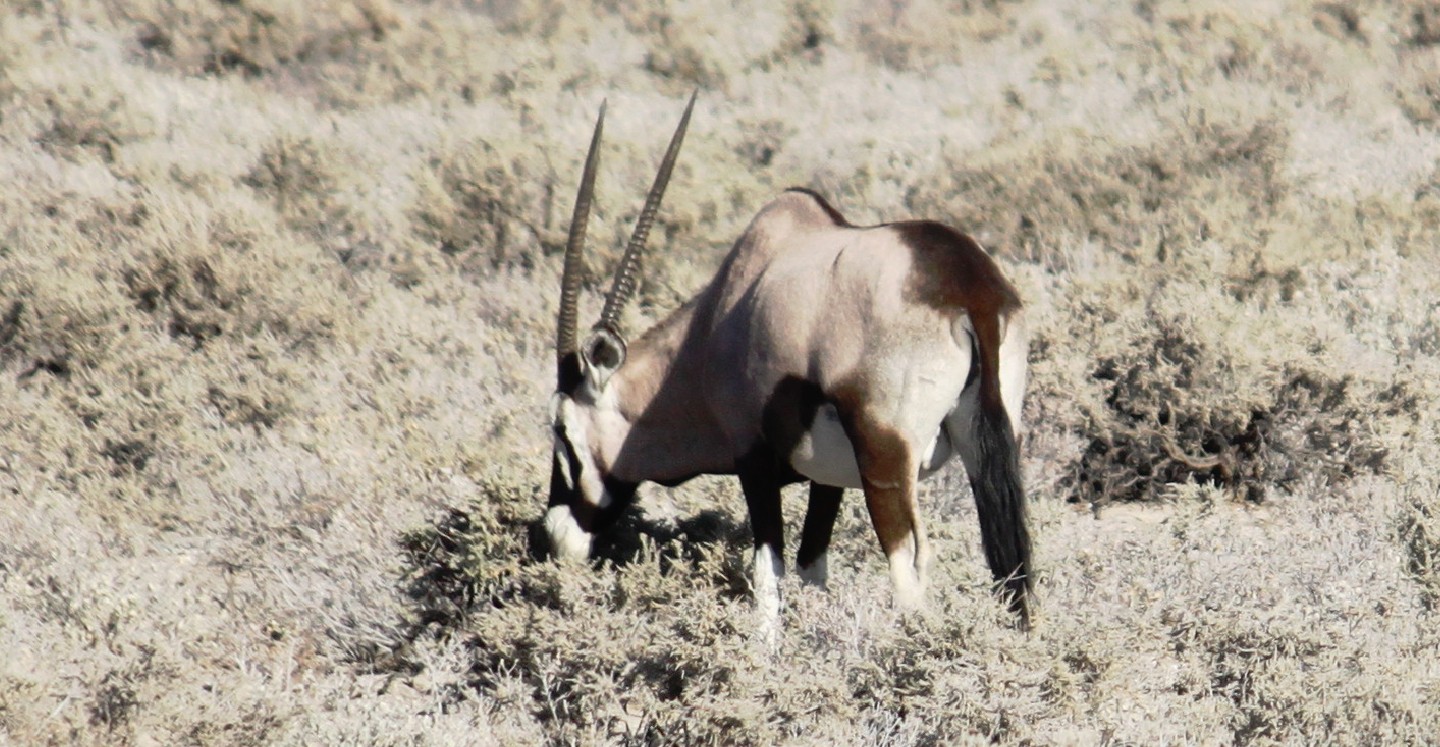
xmin=912 ymin=115 xmax=1286 ymax=263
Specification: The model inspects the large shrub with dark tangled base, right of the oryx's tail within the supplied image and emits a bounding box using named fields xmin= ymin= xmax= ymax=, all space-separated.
xmin=1031 ymin=215 xmax=1433 ymax=504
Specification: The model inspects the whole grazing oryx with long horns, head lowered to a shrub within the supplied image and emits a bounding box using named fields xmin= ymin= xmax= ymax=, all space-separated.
xmin=544 ymin=96 xmax=1031 ymax=625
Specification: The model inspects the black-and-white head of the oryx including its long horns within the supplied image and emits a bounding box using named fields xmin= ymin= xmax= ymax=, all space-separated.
xmin=544 ymin=96 xmax=696 ymax=558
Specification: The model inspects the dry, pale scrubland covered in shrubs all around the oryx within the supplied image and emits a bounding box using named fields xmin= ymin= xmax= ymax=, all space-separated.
xmin=0 ymin=0 xmax=1440 ymax=744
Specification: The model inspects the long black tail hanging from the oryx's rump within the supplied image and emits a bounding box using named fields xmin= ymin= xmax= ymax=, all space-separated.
xmin=960 ymin=317 xmax=1031 ymax=628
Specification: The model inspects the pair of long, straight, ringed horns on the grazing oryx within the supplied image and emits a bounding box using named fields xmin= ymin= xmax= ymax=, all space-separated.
xmin=554 ymin=91 xmax=700 ymax=367
